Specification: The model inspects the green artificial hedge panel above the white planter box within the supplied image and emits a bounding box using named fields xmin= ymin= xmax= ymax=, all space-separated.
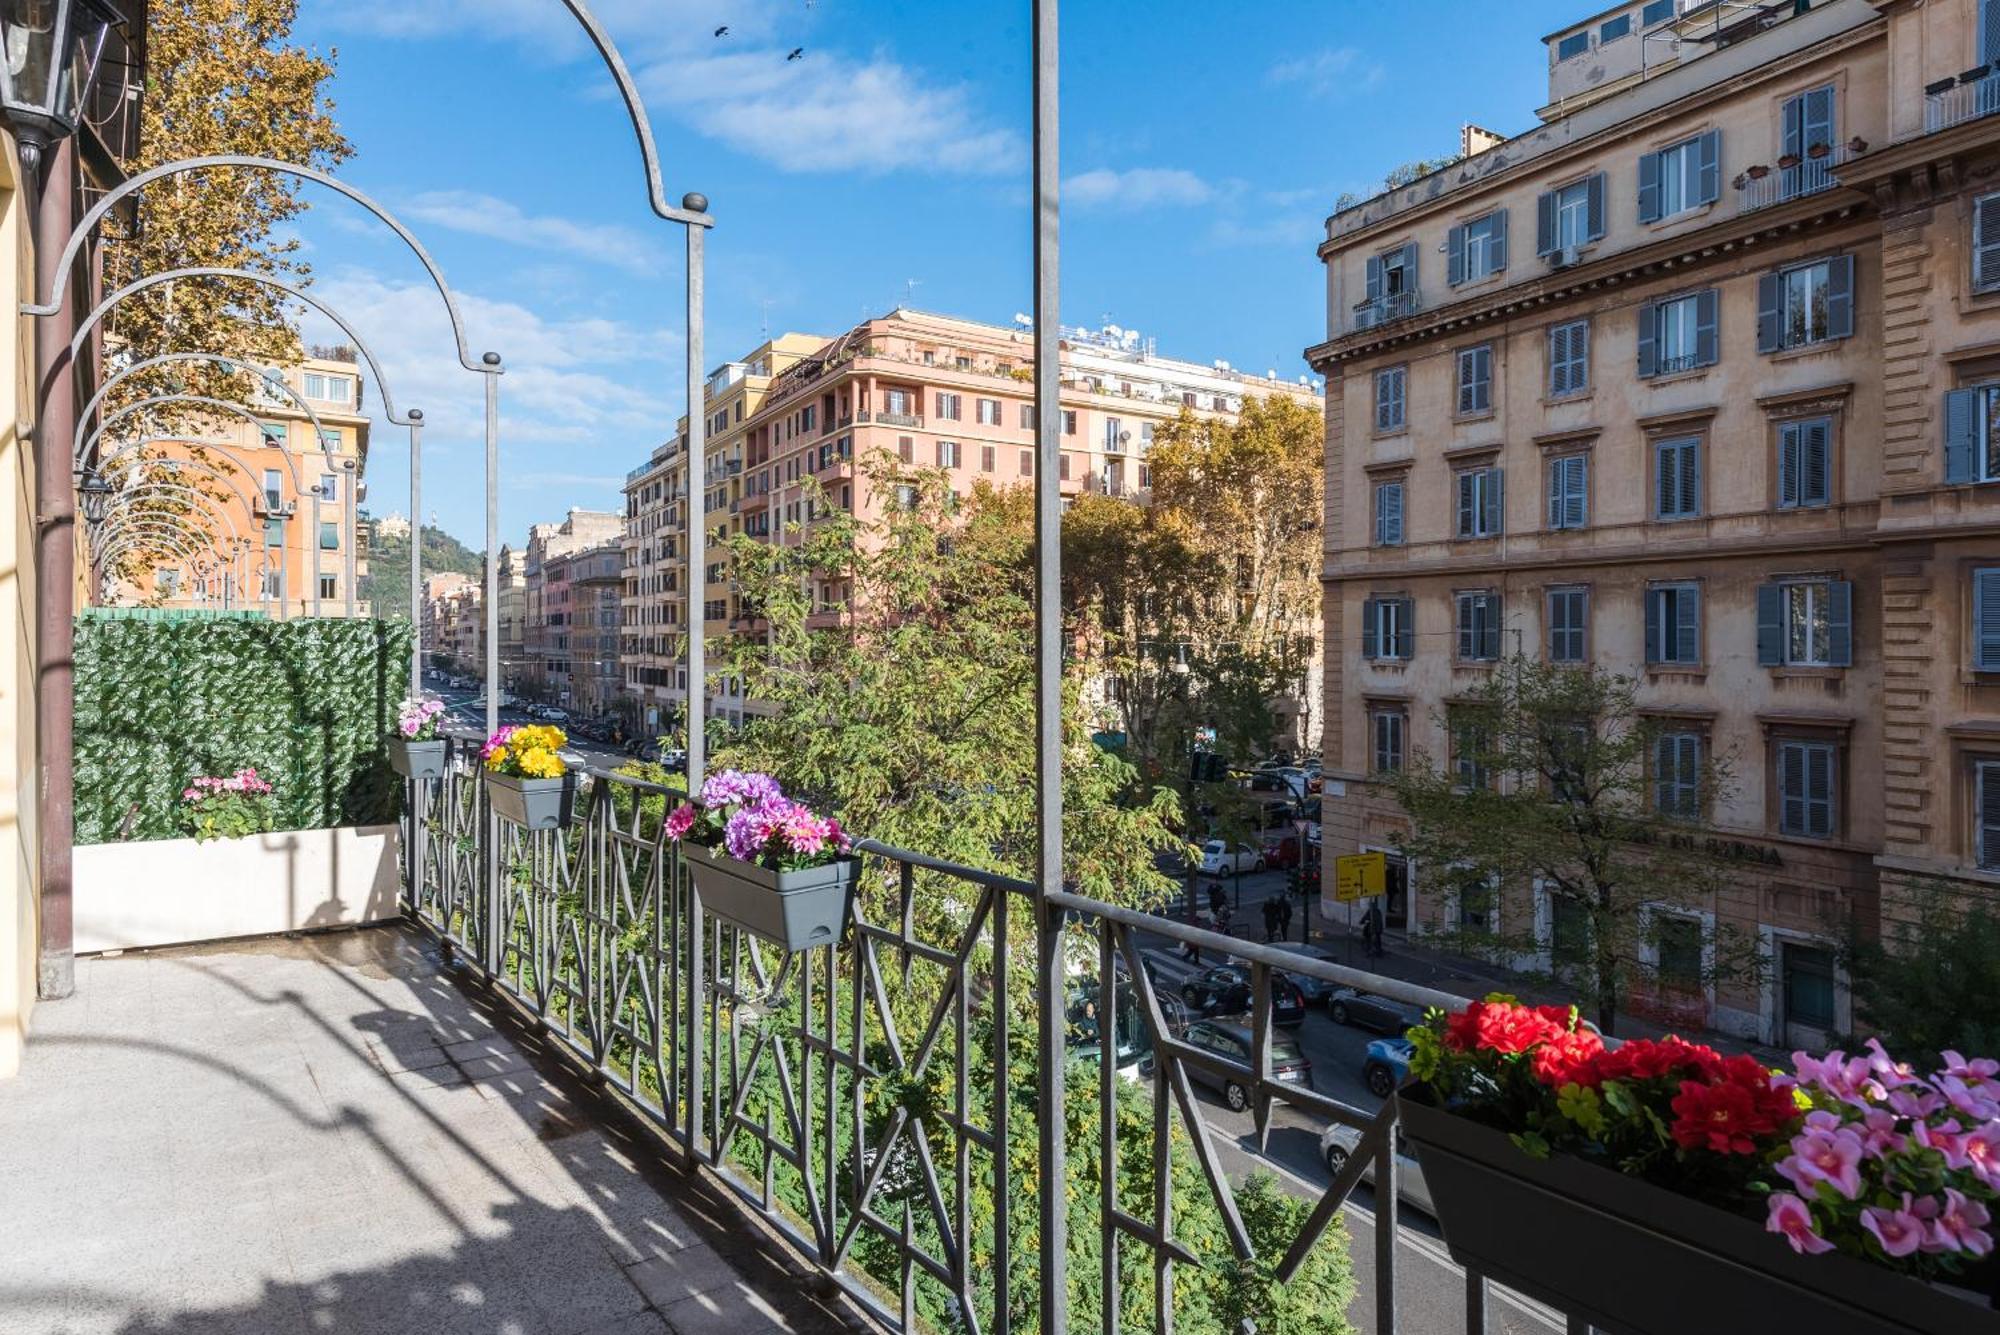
xmin=76 ymin=618 xmax=410 ymax=843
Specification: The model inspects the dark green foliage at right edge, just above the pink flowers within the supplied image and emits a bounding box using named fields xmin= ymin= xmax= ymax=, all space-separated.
xmin=1848 ymin=881 xmax=2000 ymax=1071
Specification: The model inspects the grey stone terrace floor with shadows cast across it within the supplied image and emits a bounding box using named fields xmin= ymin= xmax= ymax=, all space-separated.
xmin=0 ymin=927 xmax=848 ymax=1335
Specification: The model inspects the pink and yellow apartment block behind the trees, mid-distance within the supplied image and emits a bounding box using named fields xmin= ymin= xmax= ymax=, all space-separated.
xmin=626 ymin=310 xmax=1320 ymax=739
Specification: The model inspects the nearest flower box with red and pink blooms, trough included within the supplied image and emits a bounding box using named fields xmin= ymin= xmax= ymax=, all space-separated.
xmin=1398 ymin=997 xmax=2000 ymax=1335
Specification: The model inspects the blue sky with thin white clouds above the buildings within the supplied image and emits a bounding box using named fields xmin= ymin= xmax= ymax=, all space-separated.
xmin=296 ymin=0 xmax=1590 ymax=546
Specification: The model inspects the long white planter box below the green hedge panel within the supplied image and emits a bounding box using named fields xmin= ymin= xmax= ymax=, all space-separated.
xmin=76 ymin=825 xmax=400 ymax=955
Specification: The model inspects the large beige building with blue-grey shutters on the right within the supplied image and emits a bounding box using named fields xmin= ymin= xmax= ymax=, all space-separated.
xmin=1308 ymin=0 xmax=2000 ymax=1043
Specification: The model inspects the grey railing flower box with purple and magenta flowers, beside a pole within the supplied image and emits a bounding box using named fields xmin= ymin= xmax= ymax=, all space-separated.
xmin=666 ymin=769 xmax=858 ymax=951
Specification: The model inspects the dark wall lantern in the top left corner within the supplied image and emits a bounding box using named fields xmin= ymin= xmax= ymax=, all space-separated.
xmin=0 ymin=0 xmax=114 ymax=170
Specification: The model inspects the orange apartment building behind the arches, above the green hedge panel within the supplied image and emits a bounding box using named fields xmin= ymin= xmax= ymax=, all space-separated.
xmin=96 ymin=348 xmax=370 ymax=616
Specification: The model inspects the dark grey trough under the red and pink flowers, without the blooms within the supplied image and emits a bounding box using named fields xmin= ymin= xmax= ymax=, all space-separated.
xmin=1396 ymin=1085 xmax=2000 ymax=1335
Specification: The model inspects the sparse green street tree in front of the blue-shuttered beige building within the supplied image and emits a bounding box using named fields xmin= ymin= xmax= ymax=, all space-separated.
xmin=1384 ymin=656 xmax=1762 ymax=1033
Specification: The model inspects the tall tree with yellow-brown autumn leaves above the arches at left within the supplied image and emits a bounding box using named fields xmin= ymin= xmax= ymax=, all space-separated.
xmin=104 ymin=0 xmax=354 ymax=424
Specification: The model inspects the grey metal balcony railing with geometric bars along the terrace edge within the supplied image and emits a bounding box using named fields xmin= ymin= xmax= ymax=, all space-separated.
xmin=404 ymin=737 xmax=1486 ymax=1335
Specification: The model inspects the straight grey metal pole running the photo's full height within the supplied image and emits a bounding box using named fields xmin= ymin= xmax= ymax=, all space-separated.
xmin=1034 ymin=0 xmax=1072 ymax=1331
